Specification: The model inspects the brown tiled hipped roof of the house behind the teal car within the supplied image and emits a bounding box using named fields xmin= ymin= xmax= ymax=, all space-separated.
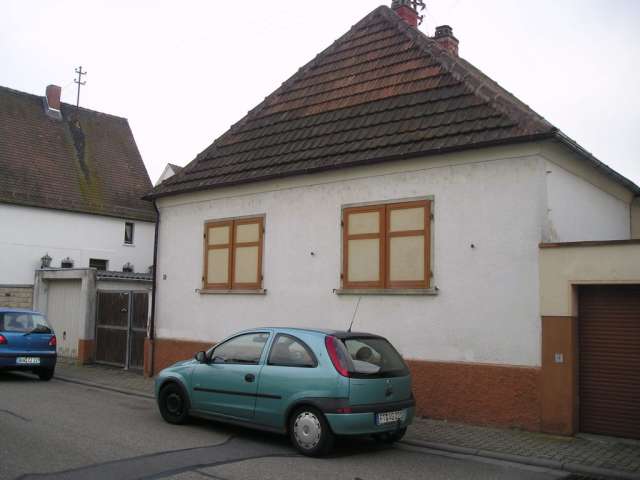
xmin=148 ymin=6 xmax=640 ymax=198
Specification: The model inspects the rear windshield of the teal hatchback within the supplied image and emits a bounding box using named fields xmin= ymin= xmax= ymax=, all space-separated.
xmin=344 ymin=338 xmax=409 ymax=377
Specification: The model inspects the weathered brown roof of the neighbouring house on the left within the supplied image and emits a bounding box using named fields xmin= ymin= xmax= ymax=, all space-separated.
xmin=0 ymin=87 xmax=156 ymax=222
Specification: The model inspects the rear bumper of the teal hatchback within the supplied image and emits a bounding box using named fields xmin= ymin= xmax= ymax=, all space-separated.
xmin=325 ymin=397 xmax=416 ymax=435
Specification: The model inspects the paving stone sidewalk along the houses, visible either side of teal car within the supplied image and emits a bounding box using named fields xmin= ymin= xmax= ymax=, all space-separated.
xmin=56 ymin=359 xmax=640 ymax=480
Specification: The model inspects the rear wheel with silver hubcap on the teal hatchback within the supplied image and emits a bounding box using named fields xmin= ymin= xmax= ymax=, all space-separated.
xmin=289 ymin=407 xmax=334 ymax=457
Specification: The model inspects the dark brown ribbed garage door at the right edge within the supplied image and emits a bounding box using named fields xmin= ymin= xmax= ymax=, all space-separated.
xmin=578 ymin=285 xmax=640 ymax=438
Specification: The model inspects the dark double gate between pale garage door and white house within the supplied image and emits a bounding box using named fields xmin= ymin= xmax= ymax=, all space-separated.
xmin=96 ymin=291 xmax=149 ymax=370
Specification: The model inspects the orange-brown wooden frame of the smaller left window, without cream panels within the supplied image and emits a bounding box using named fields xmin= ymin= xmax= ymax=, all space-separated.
xmin=202 ymin=215 xmax=264 ymax=291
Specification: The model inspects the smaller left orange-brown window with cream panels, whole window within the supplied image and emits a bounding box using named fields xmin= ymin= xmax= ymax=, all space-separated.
xmin=203 ymin=217 xmax=263 ymax=290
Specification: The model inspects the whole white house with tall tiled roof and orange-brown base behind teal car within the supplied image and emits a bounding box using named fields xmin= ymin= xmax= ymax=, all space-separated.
xmin=148 ymin=1 xmax=640 ymax=436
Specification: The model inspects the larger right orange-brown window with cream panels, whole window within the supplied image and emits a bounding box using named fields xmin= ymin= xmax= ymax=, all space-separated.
xmin=342 ymin=200 xmax=431 ymax=289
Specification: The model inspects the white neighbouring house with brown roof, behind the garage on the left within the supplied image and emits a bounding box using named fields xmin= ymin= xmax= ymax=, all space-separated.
xmin=0 ymin=85 xmax=156 ymax=362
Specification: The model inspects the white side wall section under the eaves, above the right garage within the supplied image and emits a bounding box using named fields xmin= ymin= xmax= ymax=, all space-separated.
xmin=544 ymin=144 xmax=632 ymax=242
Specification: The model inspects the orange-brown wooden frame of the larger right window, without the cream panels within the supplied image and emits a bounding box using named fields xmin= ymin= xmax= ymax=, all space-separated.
xmin=340 ymin=197 xmax=433 ymax=292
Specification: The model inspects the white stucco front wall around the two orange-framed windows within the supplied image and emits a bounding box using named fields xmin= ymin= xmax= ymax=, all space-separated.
xmin=156 ymin=146 xmax=546 ymax=366
